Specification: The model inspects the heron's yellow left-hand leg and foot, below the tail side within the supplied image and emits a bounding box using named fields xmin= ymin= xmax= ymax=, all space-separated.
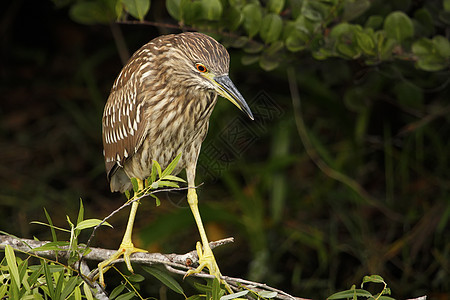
xmin=98 ymin=179 xmax=147 ymax=286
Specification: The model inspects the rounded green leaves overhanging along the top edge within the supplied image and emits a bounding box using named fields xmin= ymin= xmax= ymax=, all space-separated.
xmin=54 ymin=0 xmax=450 ymax=71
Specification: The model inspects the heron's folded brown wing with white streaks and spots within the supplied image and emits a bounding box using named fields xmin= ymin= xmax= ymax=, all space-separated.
xmin=102 ymin=66 xmax=146 ymax=179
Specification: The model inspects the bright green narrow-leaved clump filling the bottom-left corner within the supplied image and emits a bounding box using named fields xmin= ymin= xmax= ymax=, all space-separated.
xmin=0 ymin=201 xmax=105 ymax=300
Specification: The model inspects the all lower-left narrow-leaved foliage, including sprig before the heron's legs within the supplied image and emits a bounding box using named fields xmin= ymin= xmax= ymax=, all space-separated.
xmin=0 ymin=159 xmax=190 ymax=300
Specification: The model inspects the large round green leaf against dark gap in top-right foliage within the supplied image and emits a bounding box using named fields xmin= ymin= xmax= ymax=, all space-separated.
xmin=383 ymin=11 xmax=414 ymax=43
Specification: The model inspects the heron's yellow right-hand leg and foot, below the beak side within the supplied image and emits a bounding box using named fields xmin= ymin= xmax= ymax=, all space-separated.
xmin=184 ymin=188 xmax=233 ymax=293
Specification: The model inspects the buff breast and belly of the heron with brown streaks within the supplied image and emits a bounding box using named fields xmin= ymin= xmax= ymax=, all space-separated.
xmin=124 ymin=89 xmax=217 ymax=179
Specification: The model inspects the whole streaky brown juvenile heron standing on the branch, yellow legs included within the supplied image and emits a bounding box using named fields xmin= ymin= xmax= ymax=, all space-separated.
xmin=99 ymin=32 xmax=253 ymax=285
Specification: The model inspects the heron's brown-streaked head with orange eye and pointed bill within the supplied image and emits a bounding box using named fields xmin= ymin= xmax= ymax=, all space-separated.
xmin=173 ymin=32 xmax=254 ymax=120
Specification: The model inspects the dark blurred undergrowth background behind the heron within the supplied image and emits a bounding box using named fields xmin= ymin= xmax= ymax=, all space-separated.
xmin=0 ymin=1 xmax=450 ymax=299
